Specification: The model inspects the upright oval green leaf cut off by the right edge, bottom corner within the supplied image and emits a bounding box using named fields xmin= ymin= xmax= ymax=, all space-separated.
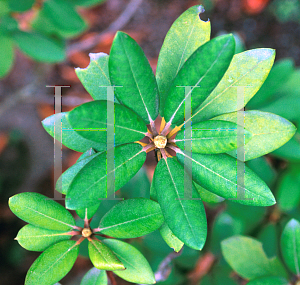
xmin=280 ymin=219 xmax=300 ymax=275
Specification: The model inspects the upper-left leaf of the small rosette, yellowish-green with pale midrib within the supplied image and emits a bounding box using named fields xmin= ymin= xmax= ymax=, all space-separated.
xmin=9 ymin=192 xmax=75 ymax=231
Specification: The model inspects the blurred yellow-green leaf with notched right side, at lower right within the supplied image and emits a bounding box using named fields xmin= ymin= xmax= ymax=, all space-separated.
xmin=221 ymin=236 xmax=285 ymax=280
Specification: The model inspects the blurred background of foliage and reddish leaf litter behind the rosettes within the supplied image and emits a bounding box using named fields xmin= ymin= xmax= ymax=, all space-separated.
xmin=0 ymin=0 xmax=300 ymax=285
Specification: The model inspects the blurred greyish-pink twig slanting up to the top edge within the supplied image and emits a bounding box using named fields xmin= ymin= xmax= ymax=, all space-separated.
xmin=67 ymin=0 xmax=143 ymax=56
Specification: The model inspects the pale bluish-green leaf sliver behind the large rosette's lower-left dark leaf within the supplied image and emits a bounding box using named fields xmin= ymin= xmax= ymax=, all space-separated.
xmin=55 ymin=150 xmax=100 ymax=195
